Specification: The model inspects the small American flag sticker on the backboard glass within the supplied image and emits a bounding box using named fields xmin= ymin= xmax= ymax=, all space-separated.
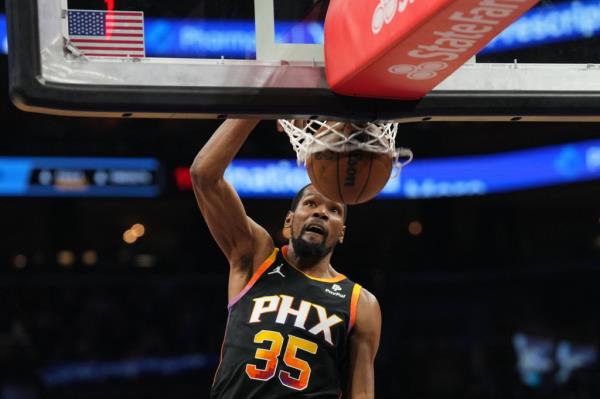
xmin=67 ymin=10 xmax=146 ymax=58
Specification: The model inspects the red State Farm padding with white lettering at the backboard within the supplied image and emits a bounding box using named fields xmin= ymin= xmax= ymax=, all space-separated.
xmin=325 ymin=0 xmax=538 ymax=100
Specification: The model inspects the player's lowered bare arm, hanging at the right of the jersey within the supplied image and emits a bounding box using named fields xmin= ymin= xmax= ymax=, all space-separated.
xmin=348 ymin=288 xmax=381 ymax=399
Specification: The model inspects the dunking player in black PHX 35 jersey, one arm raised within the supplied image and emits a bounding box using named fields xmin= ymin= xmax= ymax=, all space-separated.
xmin=191 ymin=120 xmax=381 ymax=399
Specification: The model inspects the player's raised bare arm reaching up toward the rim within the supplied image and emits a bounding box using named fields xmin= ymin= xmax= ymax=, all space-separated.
xmin=190 ymin=119 xmax=274 ymax=299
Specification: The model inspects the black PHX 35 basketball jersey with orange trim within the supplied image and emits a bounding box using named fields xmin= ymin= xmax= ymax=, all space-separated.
xmin=210 ymin=247 xmax=361 ymax=399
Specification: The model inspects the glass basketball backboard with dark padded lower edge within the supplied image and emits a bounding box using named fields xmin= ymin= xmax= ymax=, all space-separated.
xmin=7 ymin=0 xmax=600 ymax=122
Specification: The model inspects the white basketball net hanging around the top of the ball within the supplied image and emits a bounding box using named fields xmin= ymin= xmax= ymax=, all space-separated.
xmin=279 ymin=119 xmax=413 ymax=170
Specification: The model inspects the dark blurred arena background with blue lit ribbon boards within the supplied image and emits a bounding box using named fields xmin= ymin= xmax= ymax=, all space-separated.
xmin=0 ymin=1 xmax=600 ymax=399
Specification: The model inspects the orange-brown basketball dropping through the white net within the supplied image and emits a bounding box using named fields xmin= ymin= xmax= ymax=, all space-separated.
xmin=306 ymin=150 xmax=393 ymax=205
